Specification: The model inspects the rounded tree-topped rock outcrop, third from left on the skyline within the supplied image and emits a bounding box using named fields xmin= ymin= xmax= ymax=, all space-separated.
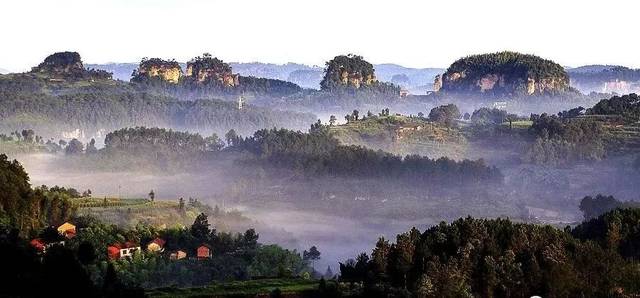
xmin=185 ymin=53 xmax=240 ymax=87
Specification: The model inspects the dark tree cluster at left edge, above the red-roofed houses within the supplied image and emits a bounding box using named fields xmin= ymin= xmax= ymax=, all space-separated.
xmin=0 ymin=154 xmax=75 ymax=235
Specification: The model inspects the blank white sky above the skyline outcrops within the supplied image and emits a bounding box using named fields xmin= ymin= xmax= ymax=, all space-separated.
xmin=0 ymin=0 xmax=640 ymax=71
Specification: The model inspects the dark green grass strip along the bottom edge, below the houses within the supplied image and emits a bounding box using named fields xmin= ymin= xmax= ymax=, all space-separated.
xmin=146 ymin=279 xmax=318 ymax=297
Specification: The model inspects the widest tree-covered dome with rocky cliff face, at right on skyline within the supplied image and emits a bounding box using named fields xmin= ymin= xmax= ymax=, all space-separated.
xmin=434 ymin=52 xmax=569 ymax=96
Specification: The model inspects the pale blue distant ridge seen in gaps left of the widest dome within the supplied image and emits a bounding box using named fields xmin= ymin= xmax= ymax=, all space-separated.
xmin=86 ymin=62 xmax=445 ymax=94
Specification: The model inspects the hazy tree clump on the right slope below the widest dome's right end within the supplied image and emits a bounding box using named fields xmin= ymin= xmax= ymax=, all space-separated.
xmin=525 ymin=114 xmax=607 ymax=165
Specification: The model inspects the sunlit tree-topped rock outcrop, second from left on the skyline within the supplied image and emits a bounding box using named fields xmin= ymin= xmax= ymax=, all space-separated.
xmin=131 ymin=58 xmax=182 ymax=84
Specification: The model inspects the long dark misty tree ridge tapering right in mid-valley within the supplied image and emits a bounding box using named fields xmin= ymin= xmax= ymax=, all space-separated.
xmin=232 ymin=127 xmax=502 ymax=184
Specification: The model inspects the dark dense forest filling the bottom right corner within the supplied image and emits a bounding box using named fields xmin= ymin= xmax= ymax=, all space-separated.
xmin=340 ymin=209 xmax=640 ymax=297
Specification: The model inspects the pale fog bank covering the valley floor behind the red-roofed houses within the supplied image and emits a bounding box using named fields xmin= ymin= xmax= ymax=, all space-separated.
xmin=16 ymin=150 xmax=638 ymax=272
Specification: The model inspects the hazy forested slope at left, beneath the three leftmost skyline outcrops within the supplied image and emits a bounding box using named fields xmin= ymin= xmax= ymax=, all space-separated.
xmin=0 ymin=74 xmax=315 ymax=139
